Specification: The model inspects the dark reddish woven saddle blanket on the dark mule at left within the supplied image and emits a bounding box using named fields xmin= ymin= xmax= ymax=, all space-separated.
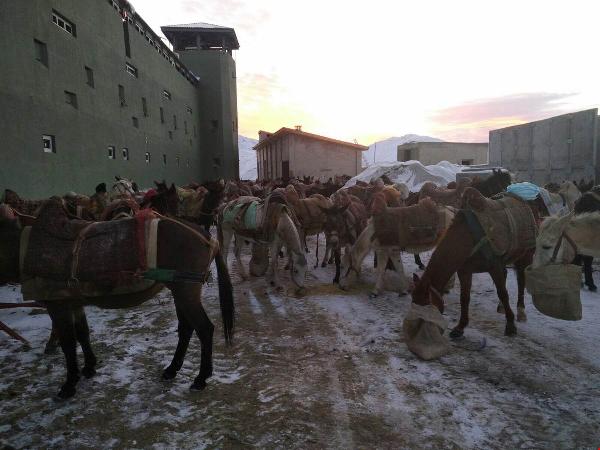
xmin=20 ymin=199 xmax=158 ymax=300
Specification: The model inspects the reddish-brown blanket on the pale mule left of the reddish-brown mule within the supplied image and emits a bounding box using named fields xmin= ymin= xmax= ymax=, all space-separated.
xmin=373 ymin=199 xmax=448 ymax=248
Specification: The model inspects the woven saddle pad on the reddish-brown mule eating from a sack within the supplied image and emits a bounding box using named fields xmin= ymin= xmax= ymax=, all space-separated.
xmin=466 ymin=193 xmax=537 ymax=262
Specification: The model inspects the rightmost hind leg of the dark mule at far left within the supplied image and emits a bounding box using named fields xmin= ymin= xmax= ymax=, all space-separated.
xmin=171 ymin=285 xmax=215 ymax=391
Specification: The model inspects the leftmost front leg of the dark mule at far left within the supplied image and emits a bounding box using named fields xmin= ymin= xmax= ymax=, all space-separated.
xmin=47 ymin=303 xmax=79 ymax=398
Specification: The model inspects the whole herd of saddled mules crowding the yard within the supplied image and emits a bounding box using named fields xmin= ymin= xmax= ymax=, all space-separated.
xmin=0 ymin=170 xmax=600 ymax=398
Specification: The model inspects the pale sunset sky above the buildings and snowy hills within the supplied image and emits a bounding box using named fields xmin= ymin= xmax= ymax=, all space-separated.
xmin=133 ymin=0 xmax=600 ymax=145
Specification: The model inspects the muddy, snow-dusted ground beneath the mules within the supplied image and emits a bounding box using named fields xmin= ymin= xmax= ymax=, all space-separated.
xmin=0 ymin=240 xmax=600 ymax=449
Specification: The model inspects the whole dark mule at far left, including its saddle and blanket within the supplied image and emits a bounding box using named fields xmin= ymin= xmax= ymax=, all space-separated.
xmin=0 ymin=199 xmax=234 ymax=398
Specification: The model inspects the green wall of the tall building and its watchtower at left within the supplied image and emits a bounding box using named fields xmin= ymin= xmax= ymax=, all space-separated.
xmin=0 ymin=0 xmax=237 ymax=198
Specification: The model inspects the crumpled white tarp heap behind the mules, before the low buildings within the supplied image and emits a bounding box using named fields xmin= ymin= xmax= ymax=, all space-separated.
xmin=344 ymin=161 xmax=469 ymax=192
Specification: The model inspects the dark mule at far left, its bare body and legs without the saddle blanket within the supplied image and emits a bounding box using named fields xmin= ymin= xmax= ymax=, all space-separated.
xmin=0 ymin=202 xmax=234 ymax=399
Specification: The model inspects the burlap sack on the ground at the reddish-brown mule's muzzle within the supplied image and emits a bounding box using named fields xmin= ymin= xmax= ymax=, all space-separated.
xmin=402 ymin=303 xmax=450 ymax=361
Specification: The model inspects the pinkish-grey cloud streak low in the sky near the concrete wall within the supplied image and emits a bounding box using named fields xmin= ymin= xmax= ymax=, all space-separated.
xmin=431 ymin=92 xmax=576 ymax=142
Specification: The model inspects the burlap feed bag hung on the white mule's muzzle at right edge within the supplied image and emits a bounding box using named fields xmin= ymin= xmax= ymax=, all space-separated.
xmin=525 ymin=264 xmax=582 ymax=320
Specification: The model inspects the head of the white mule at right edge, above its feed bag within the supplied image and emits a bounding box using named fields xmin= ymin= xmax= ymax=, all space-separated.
xmin=531 ymin=214 xmax=575 ymax=268
